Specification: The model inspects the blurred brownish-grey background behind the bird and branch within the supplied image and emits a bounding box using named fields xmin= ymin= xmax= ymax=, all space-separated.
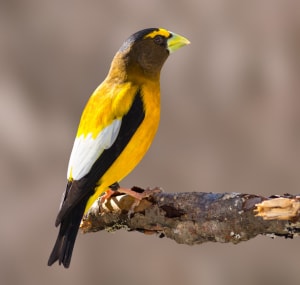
xmin=0 ymin=0 xmax=300 ymax=285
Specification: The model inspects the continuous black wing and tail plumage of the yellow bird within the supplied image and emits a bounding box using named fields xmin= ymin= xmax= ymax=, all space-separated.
xmin=48 ymin=89 xmax=145 ymax=267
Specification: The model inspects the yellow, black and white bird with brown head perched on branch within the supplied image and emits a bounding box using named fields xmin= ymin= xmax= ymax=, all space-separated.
xmin=48 ymin=28 xmax=190 ymax=268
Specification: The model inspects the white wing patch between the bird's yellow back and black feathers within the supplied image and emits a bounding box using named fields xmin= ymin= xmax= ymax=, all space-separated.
xmin=68 ymin=119 xmax=122 ymax=180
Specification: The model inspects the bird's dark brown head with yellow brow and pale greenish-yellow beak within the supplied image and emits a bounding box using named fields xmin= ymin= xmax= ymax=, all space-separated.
xmin=108 ymin=28 xmax=190 ymax=79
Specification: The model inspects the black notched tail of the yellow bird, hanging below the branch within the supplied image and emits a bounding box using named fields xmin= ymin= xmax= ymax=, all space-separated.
xmin=48 ymin=199 xmax=86 ymax=268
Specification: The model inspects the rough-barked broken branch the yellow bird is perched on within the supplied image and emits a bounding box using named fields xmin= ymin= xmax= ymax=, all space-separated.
xmin=80 ymin=187 xmax=300 ymax=245
